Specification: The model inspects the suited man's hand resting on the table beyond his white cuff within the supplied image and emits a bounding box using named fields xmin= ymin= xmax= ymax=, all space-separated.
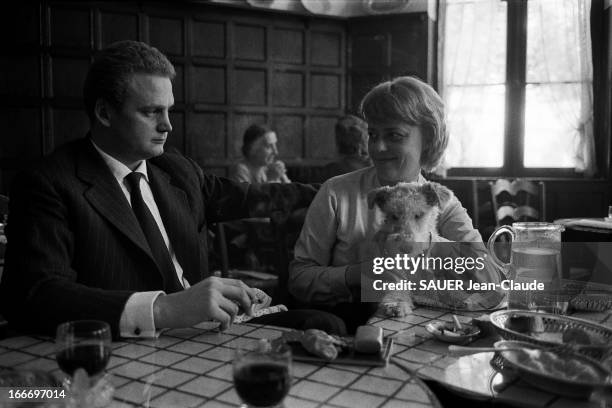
xmin=153 ymin=277 xmax=256 ymax=330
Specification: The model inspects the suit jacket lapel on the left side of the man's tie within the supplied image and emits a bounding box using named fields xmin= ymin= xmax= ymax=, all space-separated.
xmin=76 ymin=138 xmax=154 ymax=260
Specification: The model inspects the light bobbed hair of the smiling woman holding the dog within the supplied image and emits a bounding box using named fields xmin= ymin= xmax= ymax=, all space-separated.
xmin=360 ymin=76 xmax=448 ymax=171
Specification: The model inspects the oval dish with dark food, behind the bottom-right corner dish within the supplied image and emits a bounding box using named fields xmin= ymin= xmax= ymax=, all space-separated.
xmin=490 ymin=310 xmax=612 ymax=359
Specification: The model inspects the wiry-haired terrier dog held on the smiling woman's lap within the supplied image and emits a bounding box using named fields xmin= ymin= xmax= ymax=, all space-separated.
xmin=368 ymin=182 xmax=452 ymax=317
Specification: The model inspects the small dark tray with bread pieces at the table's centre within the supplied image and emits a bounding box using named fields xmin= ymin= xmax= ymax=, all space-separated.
xmin=275 ymin=326 xmax=393 ymax=366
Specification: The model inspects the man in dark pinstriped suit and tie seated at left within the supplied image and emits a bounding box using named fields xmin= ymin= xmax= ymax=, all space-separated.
xmin=0 ymin=41 xmax=344 ymax=336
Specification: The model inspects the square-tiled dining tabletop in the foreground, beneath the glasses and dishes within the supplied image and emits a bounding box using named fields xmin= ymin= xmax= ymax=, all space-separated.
xmin=0 ymin=308 xmax=612 ymax=408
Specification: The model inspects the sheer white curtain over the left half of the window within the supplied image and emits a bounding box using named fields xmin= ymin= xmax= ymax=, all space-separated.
xmin=438 ymin=0 xmax=506 ymax=173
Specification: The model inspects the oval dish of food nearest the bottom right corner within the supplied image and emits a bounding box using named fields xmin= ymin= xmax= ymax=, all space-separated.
xmin=495 ymin=340 xmax=612 ymax=398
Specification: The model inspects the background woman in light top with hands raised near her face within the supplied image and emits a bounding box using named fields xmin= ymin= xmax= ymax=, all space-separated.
xmin=229 ymin=124 xmax=291 ymax=184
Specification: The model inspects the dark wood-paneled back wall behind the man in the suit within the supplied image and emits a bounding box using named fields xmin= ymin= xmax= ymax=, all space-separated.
xmin=0 ymin=1 xmax=347 ymax=193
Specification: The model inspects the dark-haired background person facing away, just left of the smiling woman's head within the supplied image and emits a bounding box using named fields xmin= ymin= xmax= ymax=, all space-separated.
xmin=323 ymin=115 xmax=372 ymax=181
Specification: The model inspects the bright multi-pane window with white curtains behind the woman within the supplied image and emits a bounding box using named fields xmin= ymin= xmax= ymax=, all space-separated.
xmin=440 ymin=0 xmax=594 ymax=176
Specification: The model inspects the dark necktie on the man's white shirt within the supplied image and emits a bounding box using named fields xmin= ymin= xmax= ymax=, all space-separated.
xmin=125 ymin=171 xmax=183 ymax=293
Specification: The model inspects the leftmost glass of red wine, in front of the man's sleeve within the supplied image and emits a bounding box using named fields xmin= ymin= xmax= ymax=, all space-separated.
xmin=56 ymin=320 xmax=111 ymax=382
